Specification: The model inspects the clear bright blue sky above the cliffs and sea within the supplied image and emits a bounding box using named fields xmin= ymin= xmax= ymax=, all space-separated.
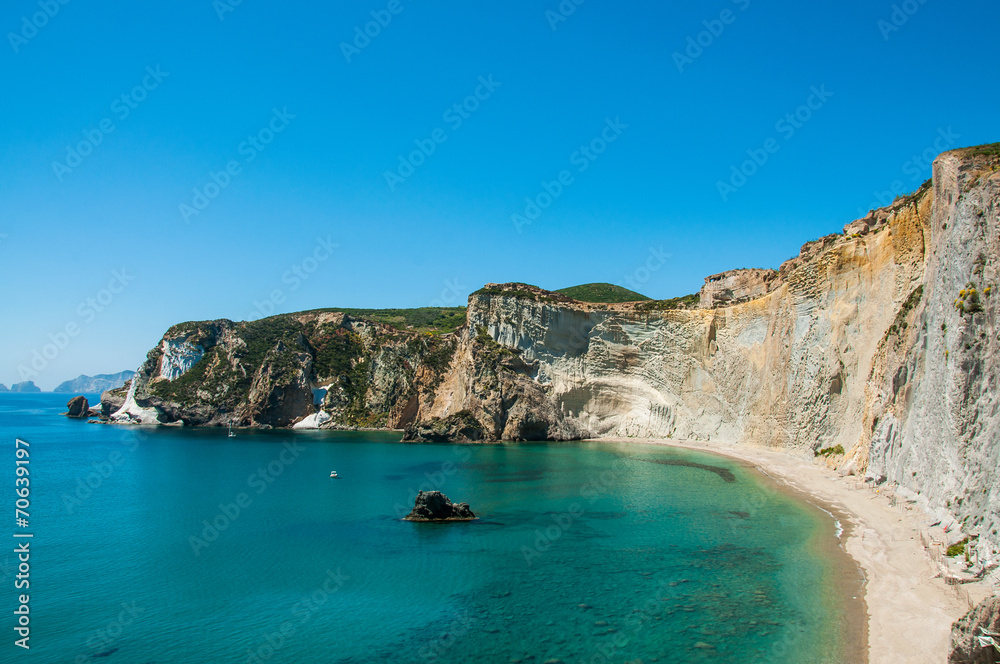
xmin=0 ymin=0 xmax=1000 ymax=389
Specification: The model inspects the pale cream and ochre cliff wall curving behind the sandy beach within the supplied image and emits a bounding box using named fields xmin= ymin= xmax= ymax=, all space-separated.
xmin=406 ymin=146 xmax=1000 ymax=559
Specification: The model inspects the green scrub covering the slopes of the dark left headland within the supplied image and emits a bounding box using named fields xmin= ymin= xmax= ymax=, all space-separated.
xmin=146 ymin=307 xmax=465 ymax=427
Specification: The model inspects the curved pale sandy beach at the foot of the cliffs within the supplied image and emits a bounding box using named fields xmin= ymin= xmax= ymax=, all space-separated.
xmin=602 ymin=438 xmax=992 ymax=664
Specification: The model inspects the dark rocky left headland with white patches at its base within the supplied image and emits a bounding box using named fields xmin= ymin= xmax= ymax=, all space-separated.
xmin=102 ymin=312 xmax=455 ymax=428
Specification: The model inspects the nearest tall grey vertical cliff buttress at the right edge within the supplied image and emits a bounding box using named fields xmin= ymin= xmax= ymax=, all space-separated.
xmin=854 ymin=149 xmax=1000 ymax=564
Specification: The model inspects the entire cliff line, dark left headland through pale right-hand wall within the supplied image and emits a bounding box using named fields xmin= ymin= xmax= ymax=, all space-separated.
xmin=105 ymin=145 xmax=1000 ymax=559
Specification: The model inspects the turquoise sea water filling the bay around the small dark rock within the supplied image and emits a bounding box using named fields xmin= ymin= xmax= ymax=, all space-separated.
xmin=0 ymin=394 xmax=849 ymax=664
